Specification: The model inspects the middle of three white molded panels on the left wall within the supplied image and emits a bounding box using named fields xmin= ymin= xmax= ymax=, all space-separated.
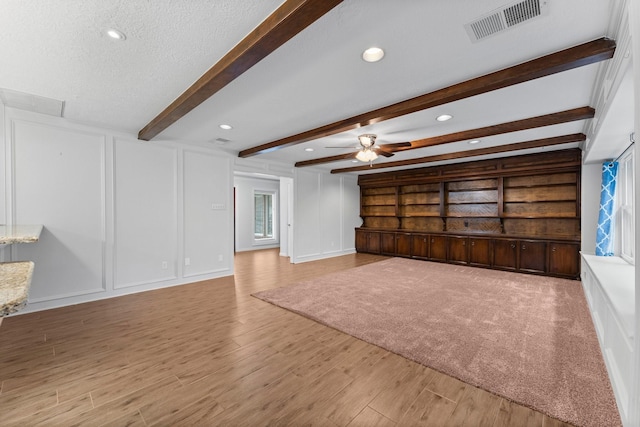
xmin=114 ymin=139 xmax=178 ymax=289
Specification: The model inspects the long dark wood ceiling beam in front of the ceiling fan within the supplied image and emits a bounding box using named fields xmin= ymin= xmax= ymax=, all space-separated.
xmin=238 ymin=38 xmax=616 ymax=157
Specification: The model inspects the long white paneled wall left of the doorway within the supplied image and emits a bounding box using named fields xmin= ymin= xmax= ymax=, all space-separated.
xmin=0 ymin=108 xmax=233 ymax=312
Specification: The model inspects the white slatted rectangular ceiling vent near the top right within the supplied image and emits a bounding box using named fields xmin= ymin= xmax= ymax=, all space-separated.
xmin=464 ymin=0 xmax=549 ymax=42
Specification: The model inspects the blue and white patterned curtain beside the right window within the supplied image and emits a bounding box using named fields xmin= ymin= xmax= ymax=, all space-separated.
xmin=596 ymin=162 xmax=618 ymax=256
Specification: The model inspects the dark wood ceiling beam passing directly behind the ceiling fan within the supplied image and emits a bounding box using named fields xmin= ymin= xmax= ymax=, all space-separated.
xmin=295 ymin=107 xmax=595 ymax=167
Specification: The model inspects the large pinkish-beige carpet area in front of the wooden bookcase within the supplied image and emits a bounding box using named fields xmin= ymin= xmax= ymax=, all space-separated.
xmin=254 ymin=258 xmax=621 ymax=426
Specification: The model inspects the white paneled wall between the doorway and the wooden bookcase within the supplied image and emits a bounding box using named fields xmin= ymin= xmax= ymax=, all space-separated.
xmin=292 ymin=168 xmax=361 ymax=263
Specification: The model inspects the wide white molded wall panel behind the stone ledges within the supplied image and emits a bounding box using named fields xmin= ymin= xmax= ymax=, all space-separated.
xmin=10 ymin=119 xmax=105 ymax=302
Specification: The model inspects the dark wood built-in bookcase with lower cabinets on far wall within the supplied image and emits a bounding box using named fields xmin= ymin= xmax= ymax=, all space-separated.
xmin=356 ymin=149 xmax=581 ymax=278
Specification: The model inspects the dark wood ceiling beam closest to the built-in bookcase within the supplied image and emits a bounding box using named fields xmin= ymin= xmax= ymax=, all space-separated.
xmin=331 ymin=133 xmax=587 ymax=173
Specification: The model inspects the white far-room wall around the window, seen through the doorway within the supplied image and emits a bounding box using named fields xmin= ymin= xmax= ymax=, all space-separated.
xmin=233 ymin=176 xmax=280 ymax=252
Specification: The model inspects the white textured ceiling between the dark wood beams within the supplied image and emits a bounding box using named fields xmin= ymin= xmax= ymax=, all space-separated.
xmin=0 ymin=0 xmax=633 ymax=174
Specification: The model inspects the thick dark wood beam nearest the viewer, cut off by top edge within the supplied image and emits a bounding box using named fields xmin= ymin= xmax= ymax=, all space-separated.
xmin=138 ymin=0 xmax=342 ymax=141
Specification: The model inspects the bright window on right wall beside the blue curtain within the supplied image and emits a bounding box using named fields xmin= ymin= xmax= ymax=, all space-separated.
xmin=616 ymin=150 xmax=635 ymax=264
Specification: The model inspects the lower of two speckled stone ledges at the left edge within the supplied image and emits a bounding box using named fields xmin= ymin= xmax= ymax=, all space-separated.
xmin=0 ymin=261 xmax=34 ymax=324
